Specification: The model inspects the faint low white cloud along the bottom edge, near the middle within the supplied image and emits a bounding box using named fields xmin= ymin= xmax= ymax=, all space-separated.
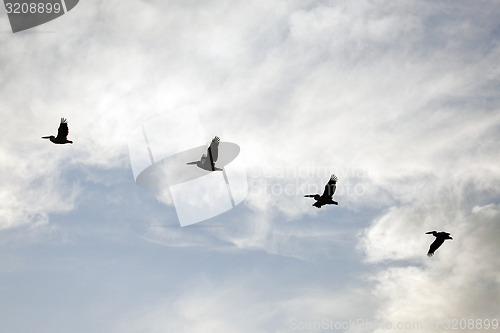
xmin=127 ymin=271 xmax=373 ymax=332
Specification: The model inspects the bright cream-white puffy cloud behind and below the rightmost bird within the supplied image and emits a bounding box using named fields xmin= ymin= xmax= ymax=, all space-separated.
xmin=364 ymin=201 xmax=500 ymax=332
